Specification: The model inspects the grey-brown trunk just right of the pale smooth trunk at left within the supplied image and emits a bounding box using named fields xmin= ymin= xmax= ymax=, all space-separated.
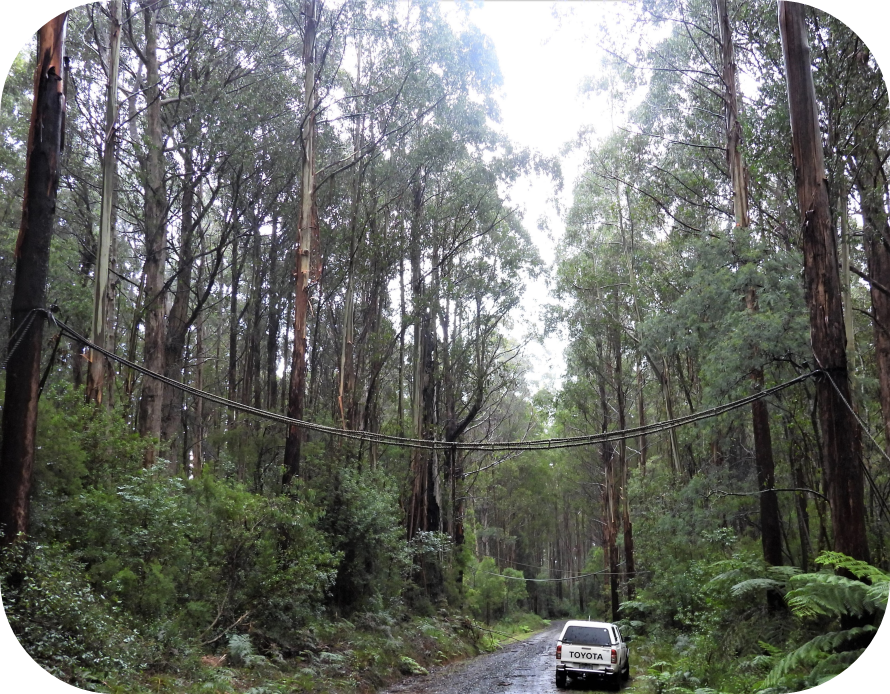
xmin=138 ymin=3 xmax=167 ymax=467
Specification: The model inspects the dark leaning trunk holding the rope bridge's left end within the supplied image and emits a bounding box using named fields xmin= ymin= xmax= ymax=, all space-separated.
xmin=0 ymin=12 xmax=68 ymax=544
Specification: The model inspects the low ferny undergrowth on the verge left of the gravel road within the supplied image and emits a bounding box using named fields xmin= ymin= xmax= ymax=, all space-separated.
xmin=8 ymin=596 xmax=491 ymax=694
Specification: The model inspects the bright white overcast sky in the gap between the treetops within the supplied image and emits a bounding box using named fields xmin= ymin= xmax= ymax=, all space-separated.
xmin=443 ymin=0 xmax=627 ymax=389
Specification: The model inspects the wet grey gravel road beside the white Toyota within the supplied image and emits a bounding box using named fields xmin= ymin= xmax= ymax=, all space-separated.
xmin=383 ymin=622 xmax=628 ymax=694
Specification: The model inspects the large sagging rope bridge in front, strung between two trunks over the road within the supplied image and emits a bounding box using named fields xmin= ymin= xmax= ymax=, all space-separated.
xmin=3 ymin=308 xmax=823 ymax=452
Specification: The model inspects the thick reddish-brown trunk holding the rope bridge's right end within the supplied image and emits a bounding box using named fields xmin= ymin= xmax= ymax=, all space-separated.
xmin=779 ymin=0 xmax=868 ymax=561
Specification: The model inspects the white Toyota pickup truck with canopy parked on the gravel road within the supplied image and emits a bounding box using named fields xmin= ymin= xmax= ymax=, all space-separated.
xmin=556 ymin=620 xmax=630 ymax=690
